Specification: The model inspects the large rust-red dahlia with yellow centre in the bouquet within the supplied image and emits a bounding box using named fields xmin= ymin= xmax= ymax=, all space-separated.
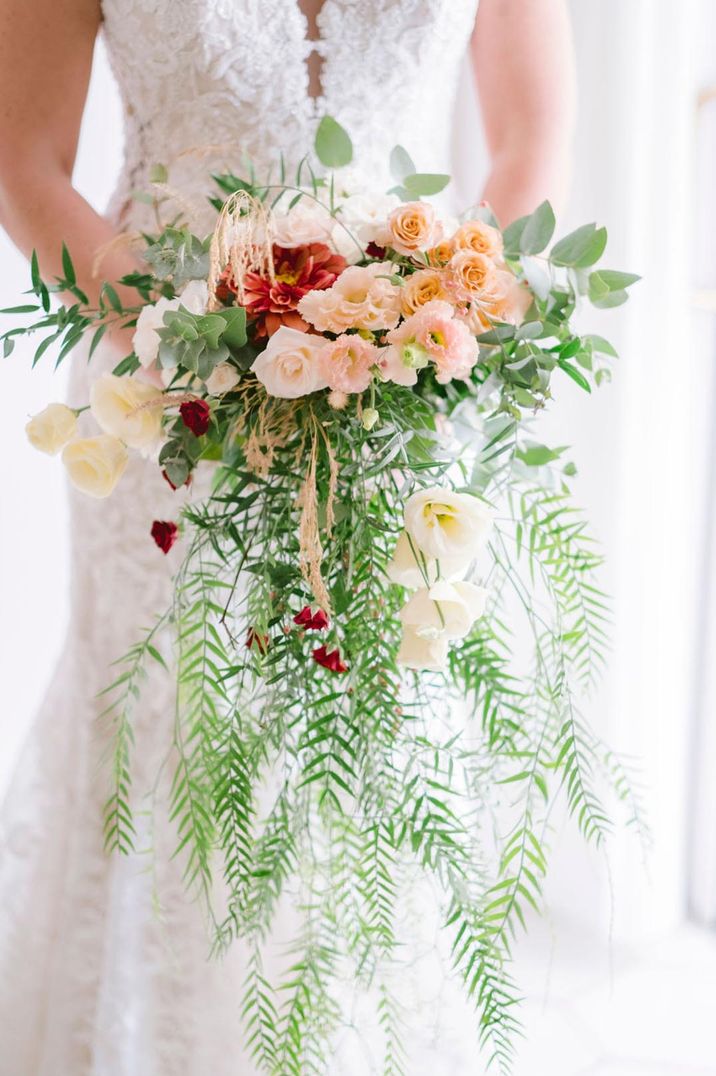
xmin=244 ymin=243 xmax=346 ymax=337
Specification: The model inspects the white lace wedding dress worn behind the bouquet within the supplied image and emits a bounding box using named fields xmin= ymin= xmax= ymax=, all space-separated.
xmin=0 ymin=0 xmax=481 ymax=1076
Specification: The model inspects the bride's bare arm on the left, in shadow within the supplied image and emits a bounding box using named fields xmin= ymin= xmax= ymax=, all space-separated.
xmin=0 ymin=0 xmax=137 ymax=318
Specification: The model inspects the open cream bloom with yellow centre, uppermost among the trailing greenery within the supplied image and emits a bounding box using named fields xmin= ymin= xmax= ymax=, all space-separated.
xmin=405 ymin=486 xmax=492 ymax=561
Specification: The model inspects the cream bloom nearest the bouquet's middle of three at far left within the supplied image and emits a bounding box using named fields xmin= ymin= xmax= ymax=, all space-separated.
xmin=89 ymin=373 xmax=164 ymax=449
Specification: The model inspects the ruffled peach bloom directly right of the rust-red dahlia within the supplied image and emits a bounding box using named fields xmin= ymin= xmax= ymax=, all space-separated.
xmin=298 ymin=261 xmax=401 ymax=334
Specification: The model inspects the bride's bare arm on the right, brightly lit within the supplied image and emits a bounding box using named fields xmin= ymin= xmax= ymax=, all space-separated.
xmin=472 ymin=0 xmax=576 ymax=225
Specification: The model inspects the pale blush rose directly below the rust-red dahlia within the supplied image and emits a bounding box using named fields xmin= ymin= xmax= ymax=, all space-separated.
xmin=251 ymin=325 xmax=327 ymax=400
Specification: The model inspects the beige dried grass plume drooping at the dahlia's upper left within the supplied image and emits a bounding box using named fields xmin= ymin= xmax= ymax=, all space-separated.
xmin=209 ymin=190 xmax=273 ymax=310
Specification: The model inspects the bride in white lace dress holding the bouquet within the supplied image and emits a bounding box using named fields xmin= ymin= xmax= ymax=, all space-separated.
xmin=0 ymin=0 xmax=573 ymax=1076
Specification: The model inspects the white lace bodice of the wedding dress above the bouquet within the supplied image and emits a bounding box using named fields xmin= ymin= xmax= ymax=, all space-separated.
xmin=102 ymin=0 xmax=478 ymax=223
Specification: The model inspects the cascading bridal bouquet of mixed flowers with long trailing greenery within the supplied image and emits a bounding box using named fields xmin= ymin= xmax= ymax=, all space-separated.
xmin=3 ymin=117 xmax=636 ymax=1076
